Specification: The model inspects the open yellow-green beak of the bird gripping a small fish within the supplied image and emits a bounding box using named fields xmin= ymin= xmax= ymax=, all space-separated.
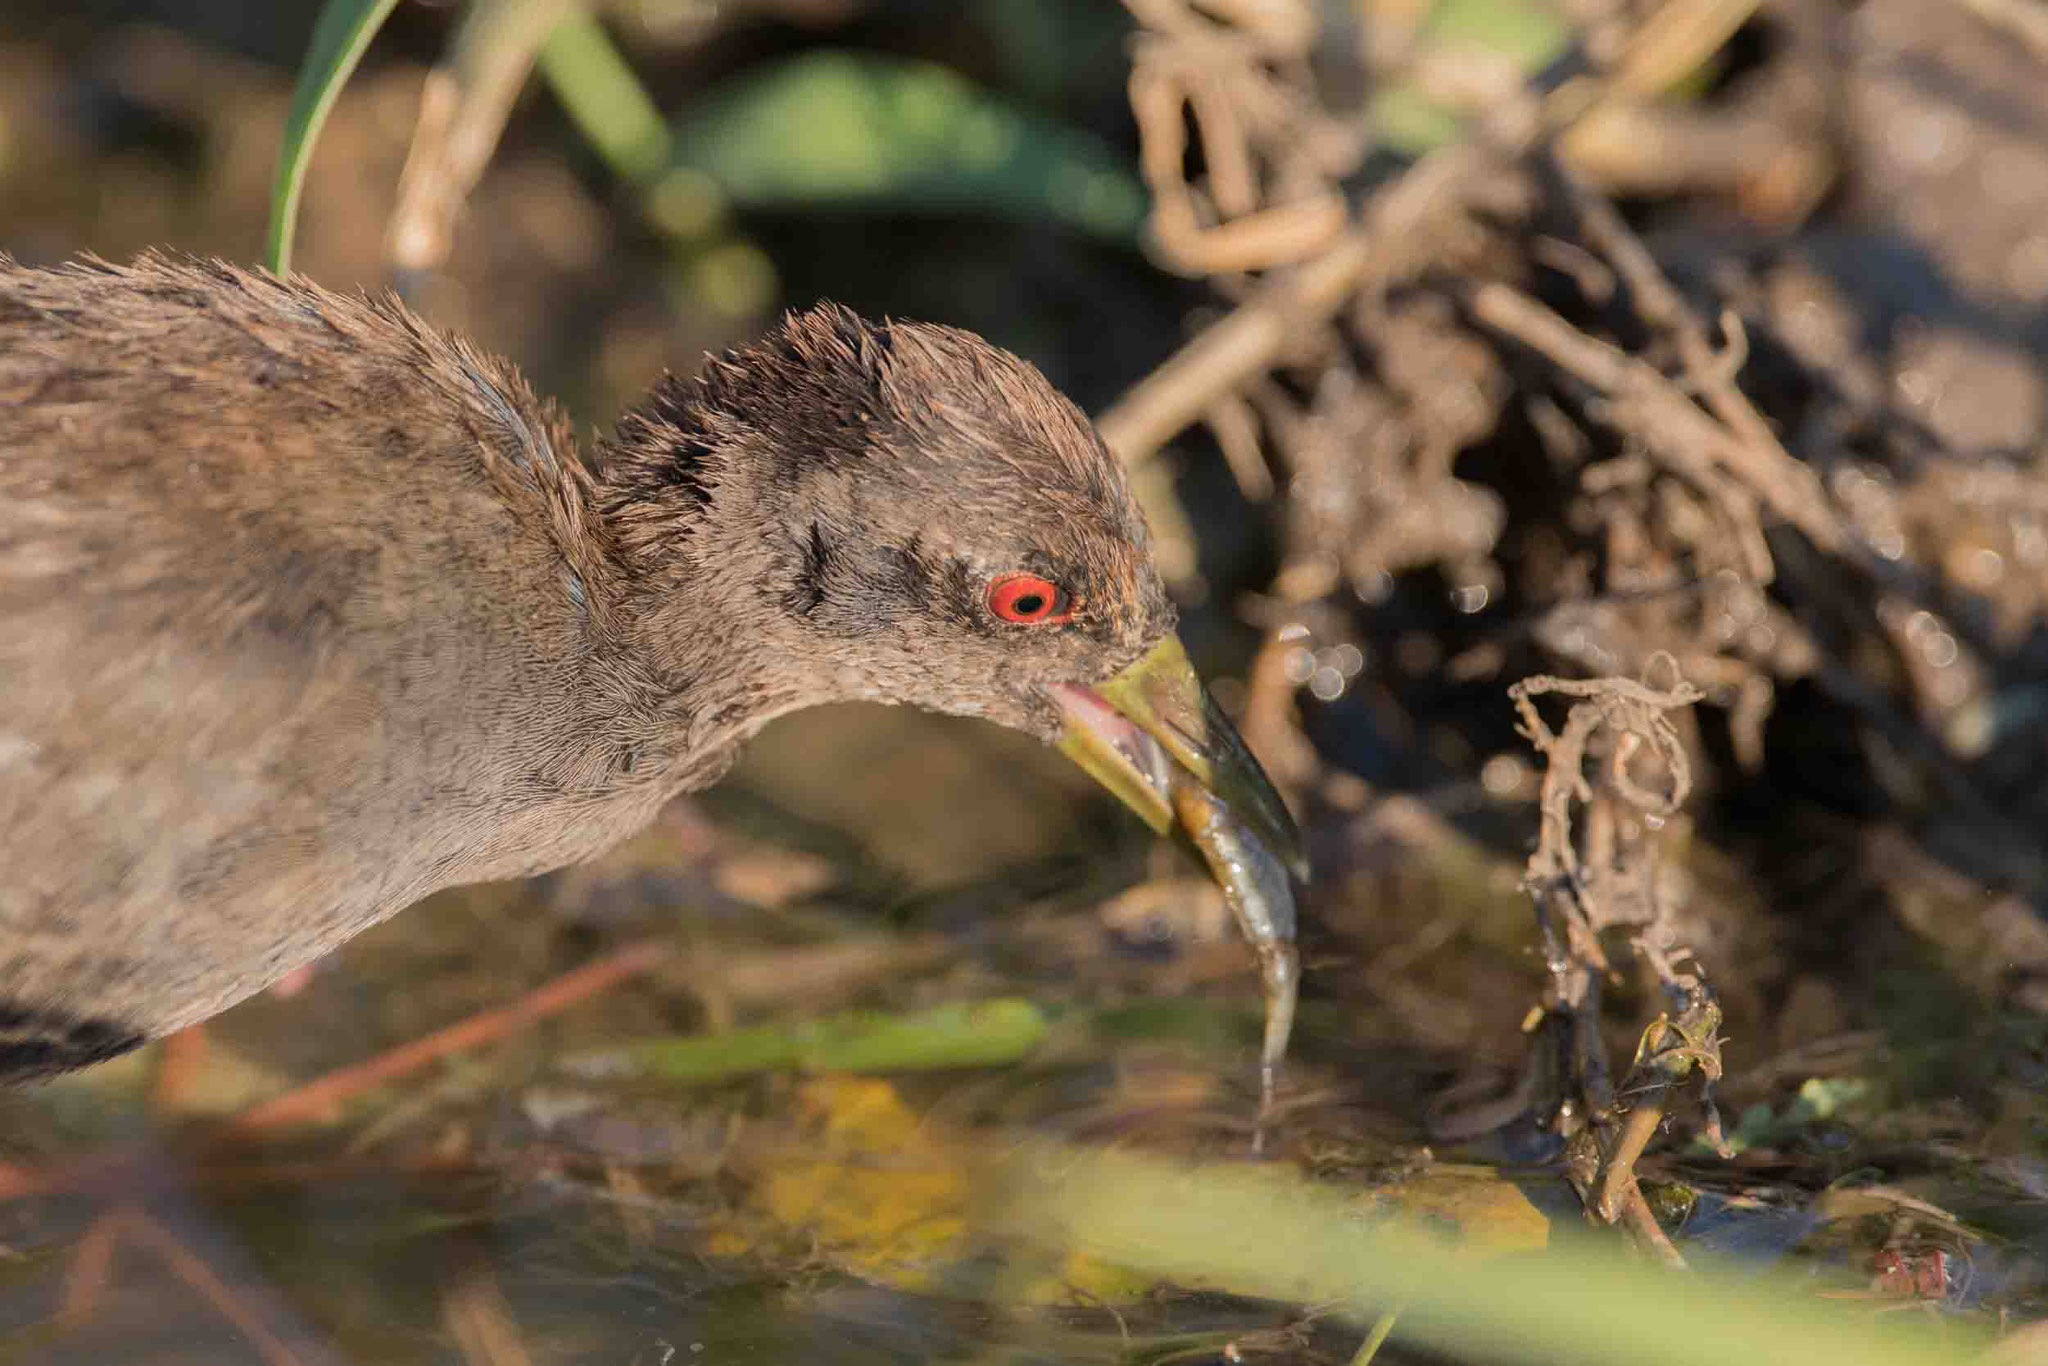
xmin=1055 ymin=635 xmax=1309 ymax=881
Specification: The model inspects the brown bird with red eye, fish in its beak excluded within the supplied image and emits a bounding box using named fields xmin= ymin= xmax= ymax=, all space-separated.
xmin=0 ymin=256 xmax=1298 ymax=1077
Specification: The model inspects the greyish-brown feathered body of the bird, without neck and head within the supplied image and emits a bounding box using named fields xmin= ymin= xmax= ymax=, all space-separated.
xmin=0 ymin=258 xmax=638 ymax=1075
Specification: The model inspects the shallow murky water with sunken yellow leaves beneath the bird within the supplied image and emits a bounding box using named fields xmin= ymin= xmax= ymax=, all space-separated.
xmin=0 ymin=727 xmax=2044 ymax=1366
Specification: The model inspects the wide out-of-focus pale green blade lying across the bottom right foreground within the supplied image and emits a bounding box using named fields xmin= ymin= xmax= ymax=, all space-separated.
xmin=989 ymin=1147 xmax=1989 ymax=1366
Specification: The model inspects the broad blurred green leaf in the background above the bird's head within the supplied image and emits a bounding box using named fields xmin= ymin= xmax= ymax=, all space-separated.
xmin=674 ymin=51 xmax=1145 ymax=242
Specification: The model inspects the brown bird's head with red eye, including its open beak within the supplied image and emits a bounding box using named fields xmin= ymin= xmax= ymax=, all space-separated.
xmin=602 ymin=305 xmax=1300 ymax=868
